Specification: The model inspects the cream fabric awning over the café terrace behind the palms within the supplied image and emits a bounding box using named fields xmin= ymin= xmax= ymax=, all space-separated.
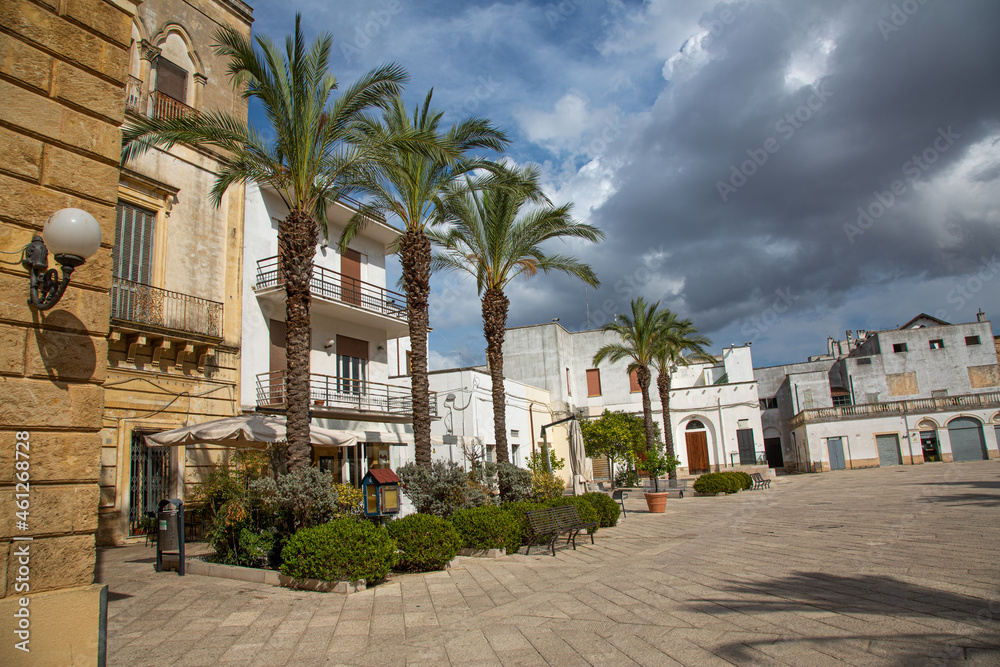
xmin=146 ymin=412 xmax=358 ymax=449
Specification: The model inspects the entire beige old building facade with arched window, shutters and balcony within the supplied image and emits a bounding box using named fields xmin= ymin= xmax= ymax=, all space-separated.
xmin=98 ymin=0 xmax=252 ymax=544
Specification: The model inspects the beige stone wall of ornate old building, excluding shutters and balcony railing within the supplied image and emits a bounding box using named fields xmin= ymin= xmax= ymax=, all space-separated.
xmin=98 ymin=0 xmax=250 ymax=544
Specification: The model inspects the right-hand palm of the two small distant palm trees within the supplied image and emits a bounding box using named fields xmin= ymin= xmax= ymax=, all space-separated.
xmin=653 ymin=308 xmax=714 ymax=479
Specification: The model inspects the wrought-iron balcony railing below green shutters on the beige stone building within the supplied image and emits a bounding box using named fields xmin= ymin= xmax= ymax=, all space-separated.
xmin=111 ymin=277 xmax=222 ymax=338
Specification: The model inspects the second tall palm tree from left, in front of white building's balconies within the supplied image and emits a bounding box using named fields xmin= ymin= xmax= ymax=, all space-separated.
xmin=340 ymin=90 xmax=508 ymax=466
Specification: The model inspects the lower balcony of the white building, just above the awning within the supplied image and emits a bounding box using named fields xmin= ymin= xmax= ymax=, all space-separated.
xmin=257 ymin=371 xmax=437 ymax=421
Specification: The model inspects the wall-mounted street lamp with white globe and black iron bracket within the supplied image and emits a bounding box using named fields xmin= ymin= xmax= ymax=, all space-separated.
xmin=21 ymin=208 xmax=101 ymax=310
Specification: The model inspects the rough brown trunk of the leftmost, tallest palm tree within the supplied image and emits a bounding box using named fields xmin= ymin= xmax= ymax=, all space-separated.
xmin=278 ymin=209 xmax=319 ymax=472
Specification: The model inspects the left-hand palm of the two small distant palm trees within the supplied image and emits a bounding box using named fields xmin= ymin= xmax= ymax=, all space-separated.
xmin=594 ymin=297 xmax=660 ymax=451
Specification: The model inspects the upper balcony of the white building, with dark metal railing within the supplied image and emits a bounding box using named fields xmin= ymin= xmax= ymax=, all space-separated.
xmin=254 ymin=257 xmax=409 ymax=338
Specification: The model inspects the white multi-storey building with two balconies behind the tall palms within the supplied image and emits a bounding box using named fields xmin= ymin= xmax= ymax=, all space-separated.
xmin=246 ymin=184 xmax=435 ymax=484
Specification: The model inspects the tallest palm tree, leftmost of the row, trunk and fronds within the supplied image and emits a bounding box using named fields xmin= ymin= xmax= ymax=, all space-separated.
xmin=122 ymin=14 xmax=422 ymax=470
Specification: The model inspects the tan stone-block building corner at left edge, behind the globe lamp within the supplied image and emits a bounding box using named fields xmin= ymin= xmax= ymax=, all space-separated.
xmin=0 ymin=0 xmax=138 ymax=665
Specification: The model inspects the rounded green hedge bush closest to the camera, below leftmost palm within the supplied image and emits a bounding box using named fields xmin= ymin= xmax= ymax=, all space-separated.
xmin=281 ymin=518 xmax=397 ymax=584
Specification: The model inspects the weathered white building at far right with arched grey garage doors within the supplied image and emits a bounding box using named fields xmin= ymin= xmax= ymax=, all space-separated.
xmin=754 ymin=315 xmax=1000 ymax=472
